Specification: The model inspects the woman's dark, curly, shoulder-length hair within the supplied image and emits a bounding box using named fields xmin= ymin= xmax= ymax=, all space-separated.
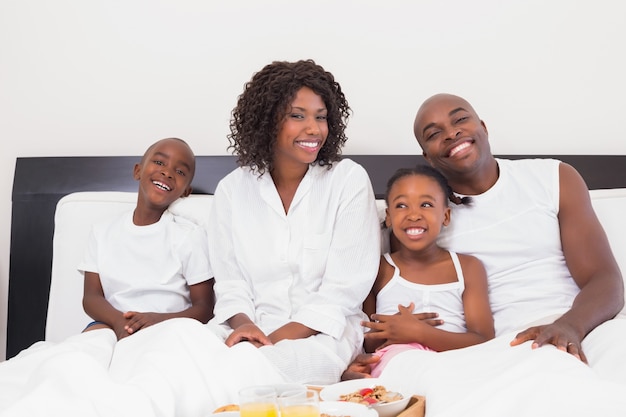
xmin=228 ymin=59 xmax=351 ymax=175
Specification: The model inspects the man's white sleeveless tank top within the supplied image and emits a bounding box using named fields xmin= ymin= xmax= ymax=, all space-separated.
xmin=439 ymin=159 xmax=585 ymax=335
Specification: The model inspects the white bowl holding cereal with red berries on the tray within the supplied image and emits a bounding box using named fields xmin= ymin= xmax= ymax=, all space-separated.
xmin=320 ymin=378 xmax=411 ymax=417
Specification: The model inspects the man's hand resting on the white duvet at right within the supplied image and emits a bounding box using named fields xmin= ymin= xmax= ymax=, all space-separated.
xmin=510 ymin=321 xmax=587 ymax=363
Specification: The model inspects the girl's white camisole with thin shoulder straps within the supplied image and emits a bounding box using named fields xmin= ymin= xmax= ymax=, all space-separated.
xmin=376 ymin=252 xmax=467 ymax=333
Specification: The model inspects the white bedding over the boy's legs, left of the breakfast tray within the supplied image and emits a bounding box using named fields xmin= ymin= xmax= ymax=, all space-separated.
xmin=0 ymin=319 xmax=283 ymax=417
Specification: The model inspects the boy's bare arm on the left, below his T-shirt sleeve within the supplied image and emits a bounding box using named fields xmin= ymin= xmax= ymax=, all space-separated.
xmin=83 ymin=271 xmax=128 ymax=339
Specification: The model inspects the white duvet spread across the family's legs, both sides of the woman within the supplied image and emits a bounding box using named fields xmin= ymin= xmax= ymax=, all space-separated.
xmin=0 ymin=319 xmax=626 ymax=417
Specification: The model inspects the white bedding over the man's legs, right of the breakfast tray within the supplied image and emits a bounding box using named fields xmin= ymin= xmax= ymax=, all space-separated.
xmin=381 ymin=320 xmax=626 ymax=417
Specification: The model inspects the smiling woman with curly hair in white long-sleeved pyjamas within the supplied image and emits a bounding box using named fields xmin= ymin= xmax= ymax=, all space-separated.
xmin=209 ymin=60 xmax=380 ymax=384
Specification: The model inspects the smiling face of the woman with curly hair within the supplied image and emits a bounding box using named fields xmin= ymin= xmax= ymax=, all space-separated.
xmin=274 ymin=87 xmax=328 ymax=171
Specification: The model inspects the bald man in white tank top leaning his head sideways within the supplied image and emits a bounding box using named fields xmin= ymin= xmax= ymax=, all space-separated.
xmin=342 ymin=94 xmax=626 ymax=381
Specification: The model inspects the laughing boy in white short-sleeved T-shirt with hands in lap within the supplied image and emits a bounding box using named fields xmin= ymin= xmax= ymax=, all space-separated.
xmin=79 ymin=138 xmax=213 ymax=340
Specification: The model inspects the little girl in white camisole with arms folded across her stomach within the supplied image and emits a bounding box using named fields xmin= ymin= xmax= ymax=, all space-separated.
xmin=362 ymin=165 xmax=494 ymax=376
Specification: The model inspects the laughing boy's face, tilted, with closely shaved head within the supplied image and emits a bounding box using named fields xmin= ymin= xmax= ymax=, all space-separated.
xmin=133 ymin=139 xmax=195 ymax=210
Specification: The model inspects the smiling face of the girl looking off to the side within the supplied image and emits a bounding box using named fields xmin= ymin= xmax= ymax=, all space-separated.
xmin=385 ymin=175 xmax=450 ymax=250
